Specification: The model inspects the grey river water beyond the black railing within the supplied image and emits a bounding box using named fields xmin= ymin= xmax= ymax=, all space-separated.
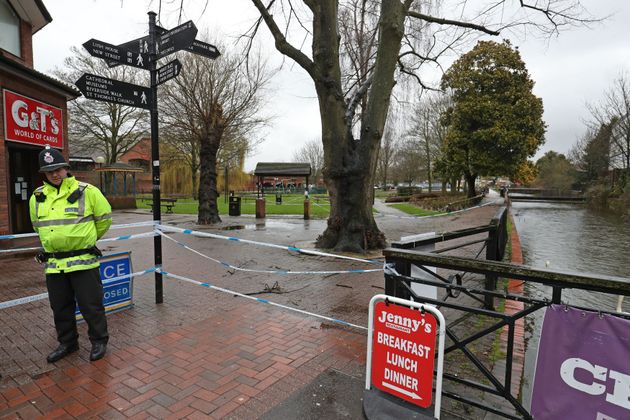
xmin=512 ymin=202 xmax=630 ymax=406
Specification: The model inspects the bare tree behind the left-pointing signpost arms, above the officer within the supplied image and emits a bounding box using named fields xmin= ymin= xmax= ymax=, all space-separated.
xmin=54 ymin=47 xmax=149 ymax=164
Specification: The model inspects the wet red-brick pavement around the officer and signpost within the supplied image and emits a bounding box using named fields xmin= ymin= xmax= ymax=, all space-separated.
xmin=0 ymin=198 xmax=498 ymax=418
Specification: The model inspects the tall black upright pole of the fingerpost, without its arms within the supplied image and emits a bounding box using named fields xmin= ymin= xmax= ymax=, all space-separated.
xmin=149 ymin=12 xmax=164 ymax=303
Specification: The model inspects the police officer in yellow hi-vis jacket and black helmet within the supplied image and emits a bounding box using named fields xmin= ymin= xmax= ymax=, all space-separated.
xmin=30 ymin=146 xmax=112 ymax=363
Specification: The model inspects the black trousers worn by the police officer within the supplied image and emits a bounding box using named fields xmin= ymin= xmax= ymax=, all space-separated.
xmin=46 ymin=267 xmax=109 ymax=344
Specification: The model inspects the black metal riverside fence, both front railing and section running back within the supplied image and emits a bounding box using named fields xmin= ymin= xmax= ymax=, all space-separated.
xmin=383 ymin=215 xmax=630 ymax=419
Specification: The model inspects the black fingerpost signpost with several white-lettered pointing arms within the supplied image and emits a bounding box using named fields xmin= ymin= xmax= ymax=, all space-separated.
xmin=75 ymin=12 xmax=220 ymax=303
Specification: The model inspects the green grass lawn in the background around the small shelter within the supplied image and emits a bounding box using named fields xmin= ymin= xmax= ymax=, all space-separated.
xmin=136 ymin=194 xmax=330 ymax=218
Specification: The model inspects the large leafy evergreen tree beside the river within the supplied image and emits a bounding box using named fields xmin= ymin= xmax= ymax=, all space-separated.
xmin=441 ymin=41 xmax=545 ymax=197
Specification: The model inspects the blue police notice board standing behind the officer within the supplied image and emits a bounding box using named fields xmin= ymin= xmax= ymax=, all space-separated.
xmin=76 ymin=252 xmax=133 ymax=319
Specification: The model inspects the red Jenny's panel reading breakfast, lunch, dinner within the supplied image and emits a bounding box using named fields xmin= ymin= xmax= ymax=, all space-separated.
xmin=372 ymin=302 xmax=437 ymax=408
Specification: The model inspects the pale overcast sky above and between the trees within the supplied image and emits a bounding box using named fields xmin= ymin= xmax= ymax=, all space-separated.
xmin=34 ymin=0 xmax=630 ymax=170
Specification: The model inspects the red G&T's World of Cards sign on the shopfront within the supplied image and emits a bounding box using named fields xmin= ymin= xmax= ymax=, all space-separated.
xmin=3 ymin=89 xmax=63 ymax=149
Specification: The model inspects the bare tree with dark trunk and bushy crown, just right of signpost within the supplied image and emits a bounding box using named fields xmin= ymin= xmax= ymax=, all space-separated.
xmin=160 ymin=43 xmax=272 ymax=224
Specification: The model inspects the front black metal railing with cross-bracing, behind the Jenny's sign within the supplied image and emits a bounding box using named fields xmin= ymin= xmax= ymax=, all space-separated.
xmin=383 ymin=248 xmax=630 ymax=419
